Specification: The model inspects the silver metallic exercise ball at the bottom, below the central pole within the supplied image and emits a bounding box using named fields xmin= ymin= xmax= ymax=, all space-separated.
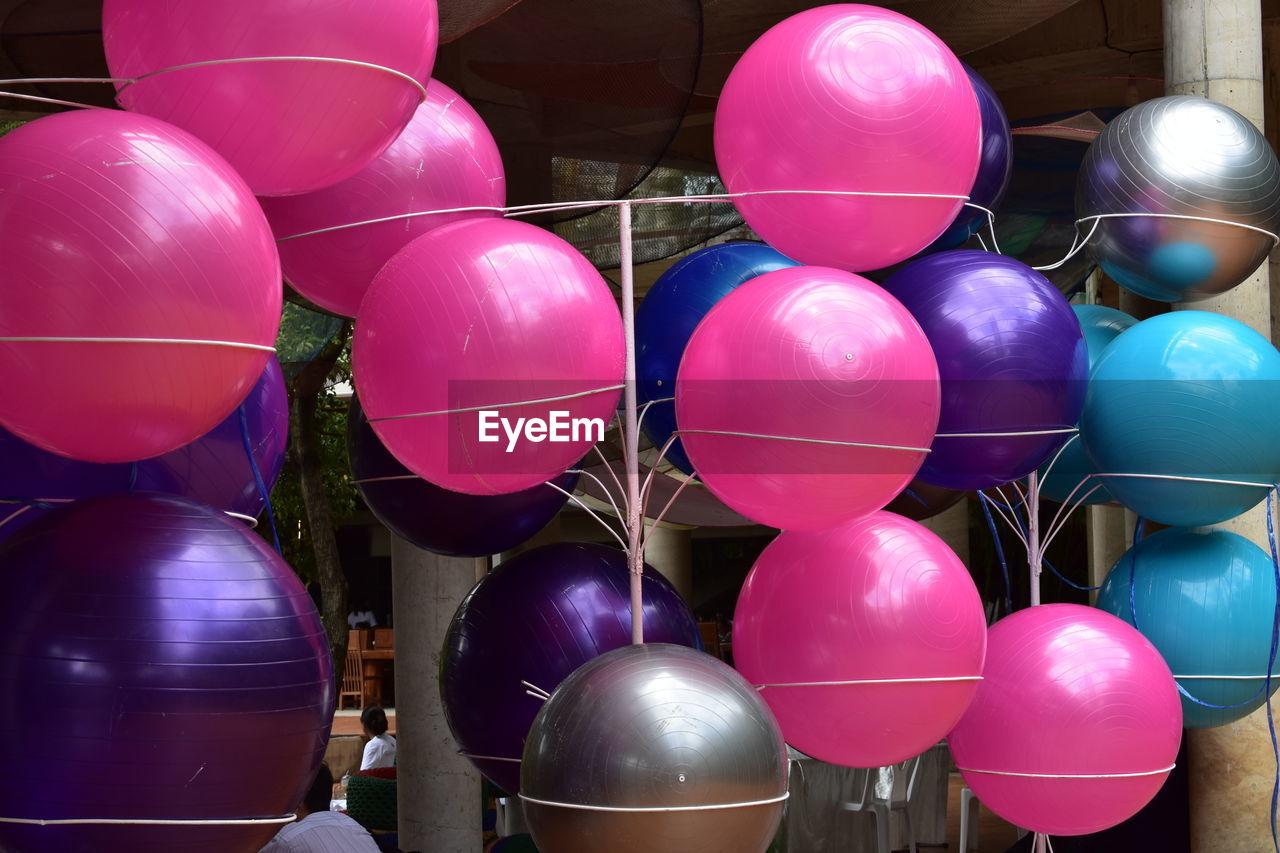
xmin=520 ymin=643 xmax=787 ymax=853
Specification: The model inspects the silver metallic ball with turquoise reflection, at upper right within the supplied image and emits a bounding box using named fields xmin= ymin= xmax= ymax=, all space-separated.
xmin=1075 ymin=95 xmax=1280 ymax=302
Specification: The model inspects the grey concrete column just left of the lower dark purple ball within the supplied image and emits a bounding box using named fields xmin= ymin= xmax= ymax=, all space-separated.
xmin=392 ymin=537 xmax=481 ymax=853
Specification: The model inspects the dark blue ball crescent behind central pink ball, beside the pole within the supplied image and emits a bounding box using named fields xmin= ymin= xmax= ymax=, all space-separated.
xmin=636 ymin=242 xmax=799 ymax=474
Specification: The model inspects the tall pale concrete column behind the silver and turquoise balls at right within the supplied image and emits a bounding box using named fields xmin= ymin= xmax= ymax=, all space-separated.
xmin=1164 ymin=0 xmax=1272 ymax=853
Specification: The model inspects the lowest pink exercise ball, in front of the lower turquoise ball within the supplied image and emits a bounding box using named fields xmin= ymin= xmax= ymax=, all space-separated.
xmin=947 ymin=605 xmax=1183 ymax=835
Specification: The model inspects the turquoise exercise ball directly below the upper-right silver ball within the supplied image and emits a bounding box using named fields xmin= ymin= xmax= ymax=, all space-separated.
xmin=1080 ymin=311 xmax=1280 ymax=528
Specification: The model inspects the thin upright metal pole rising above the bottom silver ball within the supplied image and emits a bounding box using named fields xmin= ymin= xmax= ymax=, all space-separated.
xmin=618 ymin=201 xmax=644 ymax=644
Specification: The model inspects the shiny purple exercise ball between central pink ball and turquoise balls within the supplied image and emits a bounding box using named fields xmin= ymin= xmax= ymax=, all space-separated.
xmin=884 ymin=250 xmax=1089 ymax=489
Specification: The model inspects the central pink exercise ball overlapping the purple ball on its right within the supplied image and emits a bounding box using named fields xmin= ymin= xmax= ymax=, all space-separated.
xmin=676 ymin=266 xmax=940 ymax=530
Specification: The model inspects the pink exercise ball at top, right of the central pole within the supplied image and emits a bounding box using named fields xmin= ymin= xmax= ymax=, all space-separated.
xmin=716 ymin=4 xmax=982 ymax=272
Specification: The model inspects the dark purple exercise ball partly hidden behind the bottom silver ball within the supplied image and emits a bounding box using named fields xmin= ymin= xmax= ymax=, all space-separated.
xmin=440 ymin=542 xmax=699 ymax=794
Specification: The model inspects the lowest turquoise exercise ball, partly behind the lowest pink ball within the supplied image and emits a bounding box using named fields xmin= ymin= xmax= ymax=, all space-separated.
xmin=1097 ymin=528 xmax=1280 ymax=729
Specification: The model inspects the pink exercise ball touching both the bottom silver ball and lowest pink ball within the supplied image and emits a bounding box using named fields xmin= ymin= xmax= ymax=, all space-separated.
xmin=733 ymin=512 xmax=987 ymax=767
